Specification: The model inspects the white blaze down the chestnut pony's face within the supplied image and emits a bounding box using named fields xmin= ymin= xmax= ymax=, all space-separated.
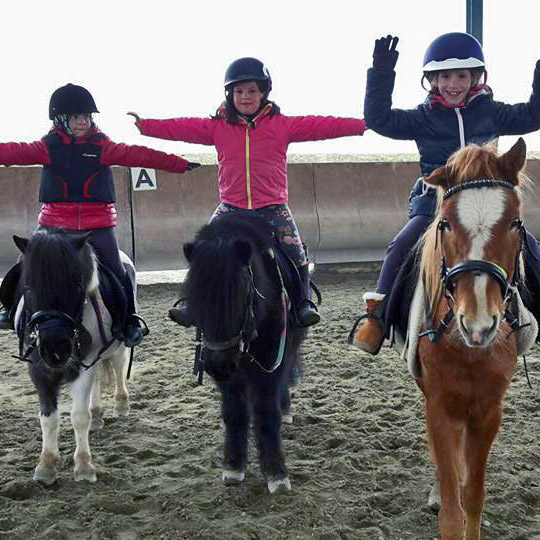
xmin=457 ymin=188 xmax=506 ymax=343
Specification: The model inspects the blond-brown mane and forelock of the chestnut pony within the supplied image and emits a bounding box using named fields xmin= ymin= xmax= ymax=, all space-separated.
xmin=419 ymin=142 xmax=532 ymax=312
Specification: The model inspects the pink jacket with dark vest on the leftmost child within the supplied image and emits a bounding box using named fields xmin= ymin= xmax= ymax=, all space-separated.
xmin=0 ymin=127 xmax=188 ymax=230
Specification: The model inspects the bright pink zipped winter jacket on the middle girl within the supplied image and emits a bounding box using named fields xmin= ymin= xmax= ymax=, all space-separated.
xmin=137 ymin=103 xmax=366 ymax=209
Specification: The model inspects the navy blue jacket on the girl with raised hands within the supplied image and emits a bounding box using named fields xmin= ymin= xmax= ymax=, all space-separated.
xmin=364 ymin=68 xmax=540 ymax=217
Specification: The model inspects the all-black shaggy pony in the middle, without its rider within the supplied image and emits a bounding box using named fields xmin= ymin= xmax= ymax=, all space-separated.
xmin=184 ymin=212 xmax=306 ymax=493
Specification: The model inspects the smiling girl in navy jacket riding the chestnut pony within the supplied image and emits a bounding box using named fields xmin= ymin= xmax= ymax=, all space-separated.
xmin=354 ymin=32 xmax=540 ymax=354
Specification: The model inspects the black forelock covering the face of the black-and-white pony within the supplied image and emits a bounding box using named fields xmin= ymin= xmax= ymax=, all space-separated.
xmin=22 ymin=229 xmax=95 ymax=310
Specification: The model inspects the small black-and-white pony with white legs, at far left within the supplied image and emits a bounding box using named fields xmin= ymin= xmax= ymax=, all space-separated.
xmin=14 ymin=229 xmax=129 ymax=485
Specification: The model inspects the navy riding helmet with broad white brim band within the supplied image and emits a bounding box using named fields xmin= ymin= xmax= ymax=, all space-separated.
xmin=423 ymin=32 xmax=485 ymax=72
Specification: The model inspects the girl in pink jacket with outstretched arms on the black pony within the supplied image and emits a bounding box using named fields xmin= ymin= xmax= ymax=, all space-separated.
xmin=128 ymin=58 xmax=366 ymax=326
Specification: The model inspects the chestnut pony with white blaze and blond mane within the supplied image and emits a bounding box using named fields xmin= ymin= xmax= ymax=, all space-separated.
xmin=409 ymin=139 xmax=536 ymax=540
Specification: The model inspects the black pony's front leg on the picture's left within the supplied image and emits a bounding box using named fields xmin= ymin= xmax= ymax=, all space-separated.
xmin=220 ymin=382 xmax=249 ymax=485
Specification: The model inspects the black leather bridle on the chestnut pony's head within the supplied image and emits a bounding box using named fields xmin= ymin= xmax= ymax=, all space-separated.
xmin=420 ymin=178 xmax=525 ymax=342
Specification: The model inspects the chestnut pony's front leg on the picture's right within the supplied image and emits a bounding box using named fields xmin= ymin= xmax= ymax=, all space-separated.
xmin=463 ymin=408 xmax=502 ymax=540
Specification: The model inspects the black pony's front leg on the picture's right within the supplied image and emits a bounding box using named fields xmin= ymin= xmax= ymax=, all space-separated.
xmin=254 ymin=382 xmax=291 ymax=493
